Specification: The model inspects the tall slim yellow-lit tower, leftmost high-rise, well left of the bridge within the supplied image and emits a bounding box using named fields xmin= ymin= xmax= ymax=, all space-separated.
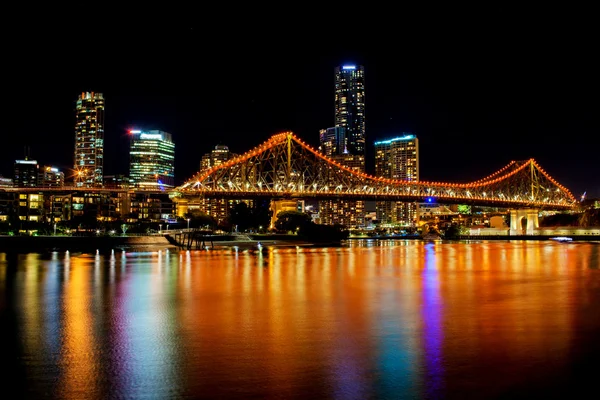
xmin=74 ymin=92 xmax=104 ymax=187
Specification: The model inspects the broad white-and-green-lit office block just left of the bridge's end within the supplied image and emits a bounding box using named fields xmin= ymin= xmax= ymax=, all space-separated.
xmin=129 ymin=130 xmax=175 ymax=190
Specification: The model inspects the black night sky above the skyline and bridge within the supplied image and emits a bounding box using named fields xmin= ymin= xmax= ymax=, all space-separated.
xmin=0 ymin=20 xmax=600 ymax=197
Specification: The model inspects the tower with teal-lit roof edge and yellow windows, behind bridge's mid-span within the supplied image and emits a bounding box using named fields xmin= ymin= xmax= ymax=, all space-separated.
xmin=375 ymin=134 xmax=419 ymax=226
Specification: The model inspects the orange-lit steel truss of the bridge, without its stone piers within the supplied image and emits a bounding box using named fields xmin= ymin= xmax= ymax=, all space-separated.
xmin=171 ymin=132 xmax=576 ymax=210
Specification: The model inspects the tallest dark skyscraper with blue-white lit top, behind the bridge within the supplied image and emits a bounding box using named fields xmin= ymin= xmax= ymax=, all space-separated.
xmin=335 ymin=65 xmax=365 ymax=155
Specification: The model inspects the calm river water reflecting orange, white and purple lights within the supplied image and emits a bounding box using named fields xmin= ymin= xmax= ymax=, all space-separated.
xmin=0 ymin=241 xmax=600 ymax=399
